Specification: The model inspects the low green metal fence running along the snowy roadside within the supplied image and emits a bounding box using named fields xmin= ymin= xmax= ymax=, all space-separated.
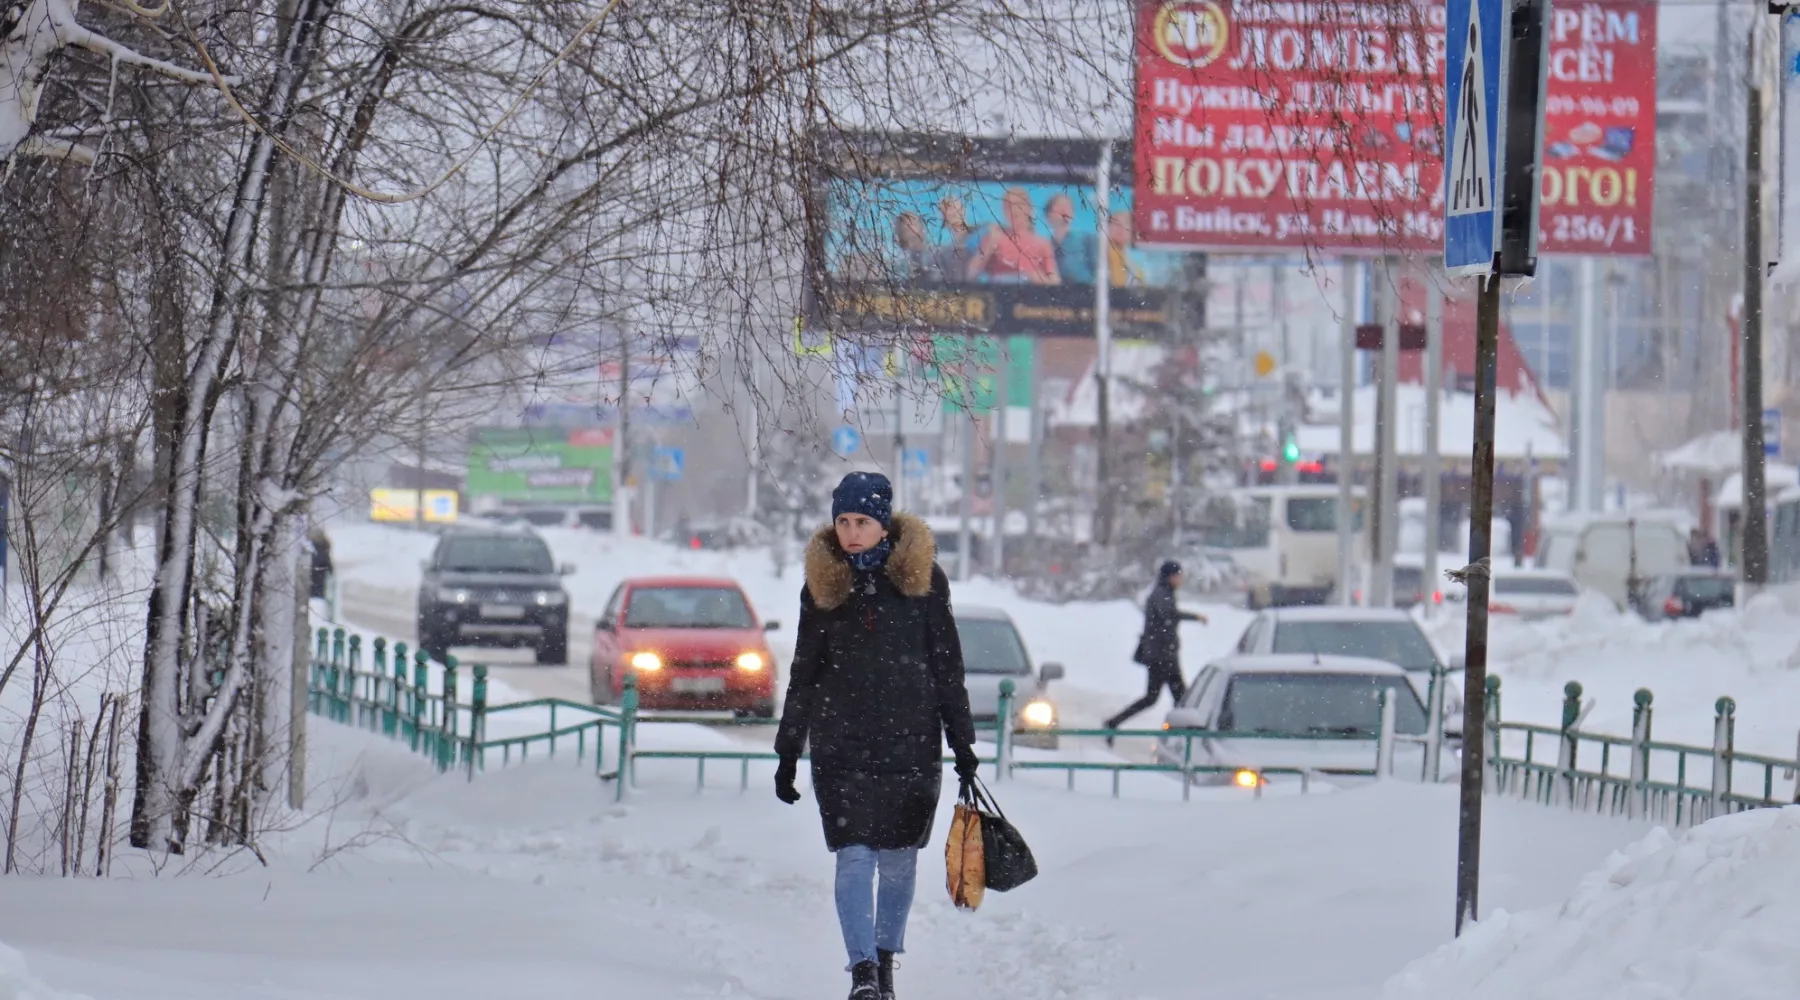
xmin=308 ymin=628 xmax=1800 ymax=826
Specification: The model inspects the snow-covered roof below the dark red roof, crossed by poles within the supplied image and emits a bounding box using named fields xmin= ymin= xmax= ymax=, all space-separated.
xmin=1294 ymin=383 xmax=1568 ymax=459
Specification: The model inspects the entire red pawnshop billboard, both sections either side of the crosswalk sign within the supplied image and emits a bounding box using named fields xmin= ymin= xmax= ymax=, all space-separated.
xmin=1134 ymin=0 xmax=1656 ymax=254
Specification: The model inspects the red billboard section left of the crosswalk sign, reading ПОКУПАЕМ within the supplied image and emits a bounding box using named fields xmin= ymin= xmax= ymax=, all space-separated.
xmin=1134 ymin=0 xmax=1444 ymax=252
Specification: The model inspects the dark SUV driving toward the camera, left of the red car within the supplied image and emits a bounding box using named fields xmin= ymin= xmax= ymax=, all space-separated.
xmin=419 ymin=527 xmax=574 ymax=664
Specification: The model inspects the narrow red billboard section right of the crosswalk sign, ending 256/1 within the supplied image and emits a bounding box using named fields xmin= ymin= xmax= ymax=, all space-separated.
xmin=1537 ymin=0 xmax=1656 ymax=254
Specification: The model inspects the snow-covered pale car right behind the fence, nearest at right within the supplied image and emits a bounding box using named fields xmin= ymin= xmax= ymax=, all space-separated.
xmin=1156 ymin=655 xmax=1454 ymax=786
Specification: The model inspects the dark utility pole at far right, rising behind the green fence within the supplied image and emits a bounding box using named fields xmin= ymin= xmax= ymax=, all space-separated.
xmin=1739 ymin=48 xmax=1769 ymax=586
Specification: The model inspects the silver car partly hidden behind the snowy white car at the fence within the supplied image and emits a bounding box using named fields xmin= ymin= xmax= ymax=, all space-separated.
xmin=1237 ymin=606 xmax=1462 ymax=734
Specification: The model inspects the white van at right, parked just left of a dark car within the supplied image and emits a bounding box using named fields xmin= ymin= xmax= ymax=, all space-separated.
xmin=1537 ymin=511 xmax=1690 ymax=610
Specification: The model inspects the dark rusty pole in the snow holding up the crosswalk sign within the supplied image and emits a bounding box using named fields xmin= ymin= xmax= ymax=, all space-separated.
xmin=1456 ymin=275 xmax=1499 ymax=935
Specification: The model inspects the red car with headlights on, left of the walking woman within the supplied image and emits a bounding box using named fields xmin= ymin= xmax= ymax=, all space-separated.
xmin=589 ymin=577 xmax=779 ymax=719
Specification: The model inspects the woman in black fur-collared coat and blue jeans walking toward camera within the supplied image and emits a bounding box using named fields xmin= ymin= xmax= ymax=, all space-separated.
xmin=776 ymin=473 xmax=979 ymax=1000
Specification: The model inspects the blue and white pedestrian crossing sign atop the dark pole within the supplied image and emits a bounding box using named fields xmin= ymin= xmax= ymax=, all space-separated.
xmin=1444 ymin=0 xmax=1510 ymax=275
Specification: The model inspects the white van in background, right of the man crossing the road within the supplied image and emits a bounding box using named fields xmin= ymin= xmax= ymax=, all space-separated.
xmin=1201 ymin=484 xmax=1368 ymax=610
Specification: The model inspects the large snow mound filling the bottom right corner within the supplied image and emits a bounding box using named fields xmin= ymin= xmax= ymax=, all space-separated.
xmin=1384 ymin=808 xmax=1800 ymax=1000
